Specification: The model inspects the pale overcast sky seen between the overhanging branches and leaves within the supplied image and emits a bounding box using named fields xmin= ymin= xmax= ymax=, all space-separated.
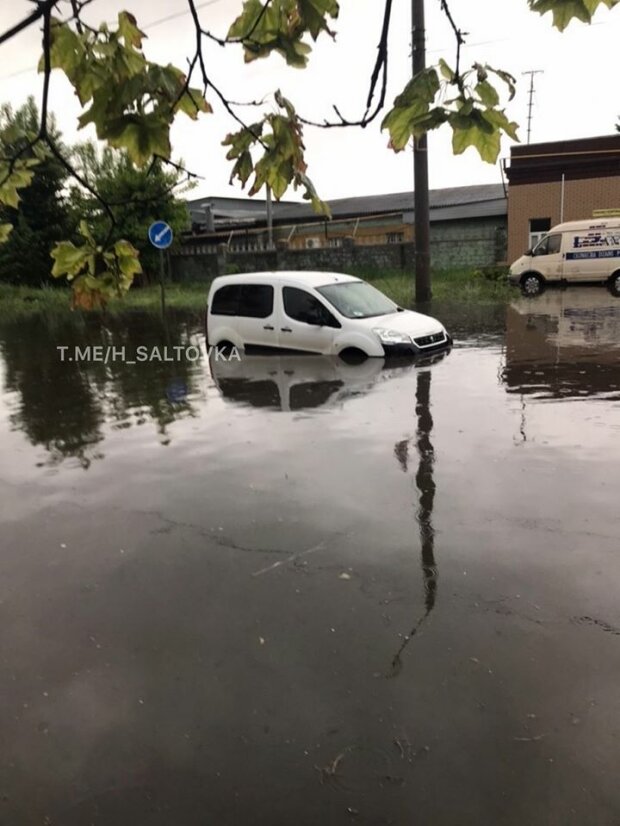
xmin=0 ymin=0 xmax=620 ymax=199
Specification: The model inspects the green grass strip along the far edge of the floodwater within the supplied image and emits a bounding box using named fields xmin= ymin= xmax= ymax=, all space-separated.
xmin=0 ymin=270 xmax=510 ymax=321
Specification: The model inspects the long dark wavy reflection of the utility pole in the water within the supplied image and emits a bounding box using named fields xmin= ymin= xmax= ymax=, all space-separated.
xmin=388 ymin=370 xmax=438 ymax=677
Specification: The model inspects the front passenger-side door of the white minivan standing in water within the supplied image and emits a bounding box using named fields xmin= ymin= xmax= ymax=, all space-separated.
xmin=279 ymin=286 xmax=340 ymax=353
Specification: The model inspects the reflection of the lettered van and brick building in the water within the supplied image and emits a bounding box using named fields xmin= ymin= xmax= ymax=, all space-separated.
xmin=504 ymin=287 xmax=620 ymax=398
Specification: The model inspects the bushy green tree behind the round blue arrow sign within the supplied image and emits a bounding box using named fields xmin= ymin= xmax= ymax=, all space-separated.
xmin=69 ymin=141 xmax=193 ymax=278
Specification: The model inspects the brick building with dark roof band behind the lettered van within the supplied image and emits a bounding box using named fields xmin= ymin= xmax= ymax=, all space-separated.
xmin=506 ymin=134 xmax=620 ymax=262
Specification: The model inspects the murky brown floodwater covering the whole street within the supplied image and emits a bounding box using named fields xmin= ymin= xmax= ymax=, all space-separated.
xmin=0 ymin=288 xmax=620 ymax=826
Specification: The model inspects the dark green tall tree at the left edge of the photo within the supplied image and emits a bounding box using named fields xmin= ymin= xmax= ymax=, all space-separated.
xmin=0 ymin=97 xmax=75 ymax=285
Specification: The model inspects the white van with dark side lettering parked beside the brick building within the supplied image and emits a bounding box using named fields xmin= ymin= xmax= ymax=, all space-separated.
xmin=509 ymin=218 xmax=620 ymax=295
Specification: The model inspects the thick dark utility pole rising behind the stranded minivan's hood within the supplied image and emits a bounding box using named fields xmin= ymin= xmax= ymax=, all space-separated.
xmin=411 ymin=0 xmax=432 ymax=304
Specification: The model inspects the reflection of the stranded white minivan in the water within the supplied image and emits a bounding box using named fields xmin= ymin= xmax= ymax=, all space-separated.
xmin=209 ymin=353 xmax=446 ymax=411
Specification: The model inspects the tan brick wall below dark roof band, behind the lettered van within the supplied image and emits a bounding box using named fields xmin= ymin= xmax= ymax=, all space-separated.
xmin=508 ymin=176 xmax=620 ymax=263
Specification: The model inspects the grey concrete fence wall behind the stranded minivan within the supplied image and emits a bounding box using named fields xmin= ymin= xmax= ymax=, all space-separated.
xmin=172 ymin=218 xmax=506 ymax=281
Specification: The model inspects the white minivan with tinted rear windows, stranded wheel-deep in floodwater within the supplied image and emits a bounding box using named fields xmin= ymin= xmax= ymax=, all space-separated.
xmin=205 ymin=271 xmax=452 ymax=358
